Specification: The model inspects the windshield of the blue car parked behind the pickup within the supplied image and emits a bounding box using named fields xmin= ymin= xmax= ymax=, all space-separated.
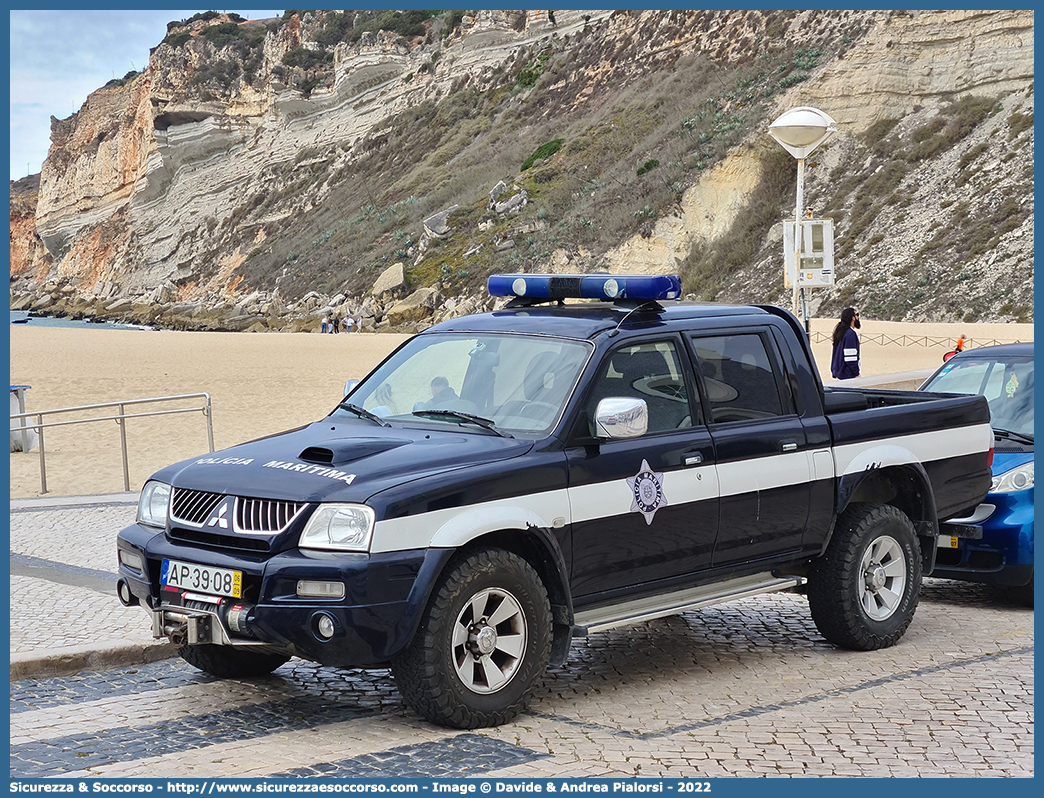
xmin=924 ymin=356 xmax=1034 ymax=436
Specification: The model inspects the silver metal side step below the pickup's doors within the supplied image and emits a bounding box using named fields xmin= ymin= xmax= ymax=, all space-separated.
xmin=573 ymin=573 xmax=805 ymax=637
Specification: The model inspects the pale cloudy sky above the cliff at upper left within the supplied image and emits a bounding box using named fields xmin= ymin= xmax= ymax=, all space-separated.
xmin=10 ymin=8 xmax=283 ymax=180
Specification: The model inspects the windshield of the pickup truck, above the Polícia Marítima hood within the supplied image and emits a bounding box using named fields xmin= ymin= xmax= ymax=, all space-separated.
xmin=334 ymin=333 xmax=591 ymax=437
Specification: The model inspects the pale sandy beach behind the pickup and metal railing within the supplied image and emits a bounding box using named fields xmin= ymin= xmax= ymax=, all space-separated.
xmin=10 ymin=319 xmax=1034 ymax=498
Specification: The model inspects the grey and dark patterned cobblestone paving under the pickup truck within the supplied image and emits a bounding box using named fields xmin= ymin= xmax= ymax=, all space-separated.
xmin=10 ymin=494 xmax=1034 ymax=778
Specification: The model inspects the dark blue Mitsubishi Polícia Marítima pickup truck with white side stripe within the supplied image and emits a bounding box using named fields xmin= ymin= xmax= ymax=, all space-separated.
xmin=118 ymin=275 xmax=994 ymax=728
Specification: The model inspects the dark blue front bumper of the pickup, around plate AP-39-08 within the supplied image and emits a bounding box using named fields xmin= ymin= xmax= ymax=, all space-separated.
xmin=117 ymin=524 xmax=452 ymax=667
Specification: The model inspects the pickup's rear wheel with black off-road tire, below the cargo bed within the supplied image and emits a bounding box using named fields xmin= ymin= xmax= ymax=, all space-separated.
xmin=808 ymin=503 xmax=921 ymax=651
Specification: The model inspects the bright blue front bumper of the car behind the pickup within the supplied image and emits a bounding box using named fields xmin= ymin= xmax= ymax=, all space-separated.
xmin=931 ymin=489 xmax=1034 ymax=586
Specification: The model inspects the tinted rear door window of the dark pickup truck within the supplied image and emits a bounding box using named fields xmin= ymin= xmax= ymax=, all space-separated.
xmin=692 ymin=333 xmax=784 ymax=424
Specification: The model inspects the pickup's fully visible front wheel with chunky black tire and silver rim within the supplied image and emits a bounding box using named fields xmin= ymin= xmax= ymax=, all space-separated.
xmin=392 ymin=548 xmax=551 ymax=729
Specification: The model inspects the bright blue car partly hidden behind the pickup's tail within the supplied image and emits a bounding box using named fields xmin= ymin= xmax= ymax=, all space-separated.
xmin=920 ymin=343 xmax=1034 ymax=607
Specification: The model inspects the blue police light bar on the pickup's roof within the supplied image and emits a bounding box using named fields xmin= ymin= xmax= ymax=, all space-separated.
xmin=487 ymin=275 xmax=682 ymax=300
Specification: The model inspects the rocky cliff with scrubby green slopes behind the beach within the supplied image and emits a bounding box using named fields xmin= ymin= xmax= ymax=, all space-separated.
xmin=10 ymin=10 xmax=1034 ymax=329
